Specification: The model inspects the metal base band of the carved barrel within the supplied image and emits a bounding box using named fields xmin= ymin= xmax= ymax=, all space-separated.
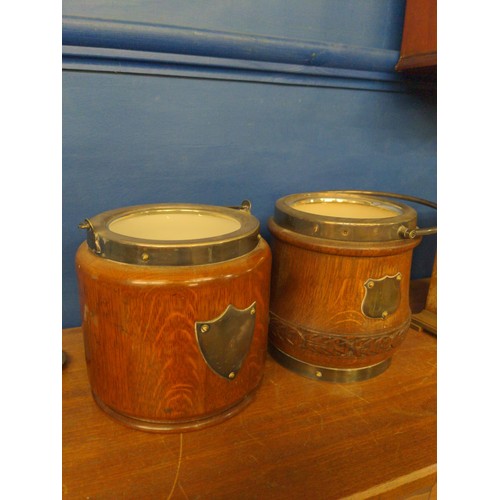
xmin=269 ymin=344 xmax=391 ymax=383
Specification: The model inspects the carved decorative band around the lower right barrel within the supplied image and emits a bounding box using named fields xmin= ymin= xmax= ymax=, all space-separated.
xmin=269 ymin=312 xmax=411 ymax=358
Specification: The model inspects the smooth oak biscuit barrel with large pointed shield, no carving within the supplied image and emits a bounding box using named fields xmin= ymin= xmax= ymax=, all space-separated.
xmin=76 ymin=202 xmax=271 ymax=431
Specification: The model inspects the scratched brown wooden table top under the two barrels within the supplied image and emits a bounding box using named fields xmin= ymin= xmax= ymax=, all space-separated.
xmin=62 ymin=318 xmax=437 ymax=500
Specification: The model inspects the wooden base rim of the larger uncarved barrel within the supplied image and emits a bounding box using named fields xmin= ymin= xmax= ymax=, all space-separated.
xmin=92 ymin=389 xmax=256 ymax=433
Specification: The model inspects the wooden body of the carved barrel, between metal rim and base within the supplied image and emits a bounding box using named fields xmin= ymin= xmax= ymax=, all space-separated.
xmin=269 ymin=219 xmax=421 ymax=369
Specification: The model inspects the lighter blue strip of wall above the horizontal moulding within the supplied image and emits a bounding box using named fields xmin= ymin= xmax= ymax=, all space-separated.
xmin=62 ymin=0 xmax=405 ymax=50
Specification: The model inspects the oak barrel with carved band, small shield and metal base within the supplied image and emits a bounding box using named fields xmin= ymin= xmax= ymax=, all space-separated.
xmin=269 ymin=191 xmax=436 ymax=382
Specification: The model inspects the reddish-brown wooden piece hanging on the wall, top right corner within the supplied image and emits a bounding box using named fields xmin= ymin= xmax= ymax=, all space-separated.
xmin=396 ymin=0 xmax=437 ymax=71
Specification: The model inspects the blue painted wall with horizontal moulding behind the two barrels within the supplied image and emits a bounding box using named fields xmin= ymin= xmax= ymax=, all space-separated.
xmin=62 ymin=0 xmax=436 ymax=327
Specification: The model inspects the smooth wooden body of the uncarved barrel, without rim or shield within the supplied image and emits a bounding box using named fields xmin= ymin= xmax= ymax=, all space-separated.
xmin=76 ymin=238 xmax=271 ymax=427
